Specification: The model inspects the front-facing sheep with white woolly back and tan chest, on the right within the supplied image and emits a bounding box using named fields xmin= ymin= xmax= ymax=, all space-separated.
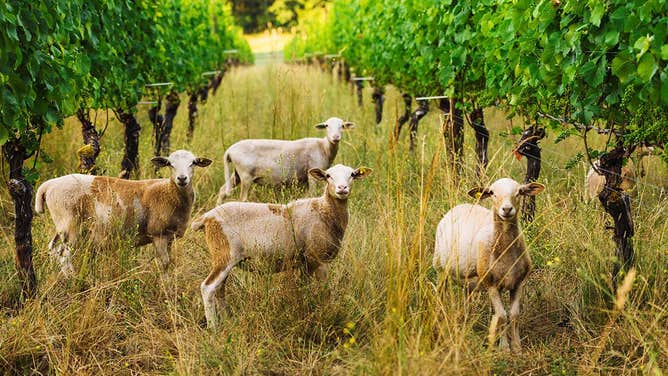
xmin=433 ymin=178 xmax=545 ymax=351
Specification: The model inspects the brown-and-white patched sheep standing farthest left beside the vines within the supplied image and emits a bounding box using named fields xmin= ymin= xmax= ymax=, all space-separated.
xmin=35 ymin=150 xmax=211 ymax=275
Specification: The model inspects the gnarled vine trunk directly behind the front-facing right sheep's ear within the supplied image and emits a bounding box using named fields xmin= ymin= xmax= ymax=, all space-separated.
xmin=515 ymin=125 xmax=545 ymax=222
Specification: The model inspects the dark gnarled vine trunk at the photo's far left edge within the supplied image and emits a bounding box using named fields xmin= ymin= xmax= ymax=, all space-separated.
xmin=2 ymin=139 xmax=37 ymax=297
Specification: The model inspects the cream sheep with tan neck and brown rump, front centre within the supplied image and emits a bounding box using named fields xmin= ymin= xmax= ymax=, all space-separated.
xmin=191 ymin=164 xmax=373 ymax=328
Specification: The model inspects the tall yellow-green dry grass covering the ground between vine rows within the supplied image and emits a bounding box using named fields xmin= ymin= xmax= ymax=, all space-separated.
xmin=0 ymin=65 xmax=668 ymax=375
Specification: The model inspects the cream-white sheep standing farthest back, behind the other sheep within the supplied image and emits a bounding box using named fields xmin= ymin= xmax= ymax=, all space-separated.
xmin=217 ymin=117 xmax=355 ymax=205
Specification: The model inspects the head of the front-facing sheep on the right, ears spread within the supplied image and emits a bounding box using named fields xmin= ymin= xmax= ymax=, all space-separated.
xmin=469 ymin=178 xmax=545 ymax=221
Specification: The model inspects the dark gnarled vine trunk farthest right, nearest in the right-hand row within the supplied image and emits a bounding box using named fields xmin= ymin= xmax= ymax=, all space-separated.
xmin=598 ymin=144 xmax=635 ymax=283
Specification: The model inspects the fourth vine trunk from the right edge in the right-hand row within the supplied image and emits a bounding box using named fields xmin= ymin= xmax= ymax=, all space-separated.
xmin=438 ymin=98 xmax=464 ymax=172
